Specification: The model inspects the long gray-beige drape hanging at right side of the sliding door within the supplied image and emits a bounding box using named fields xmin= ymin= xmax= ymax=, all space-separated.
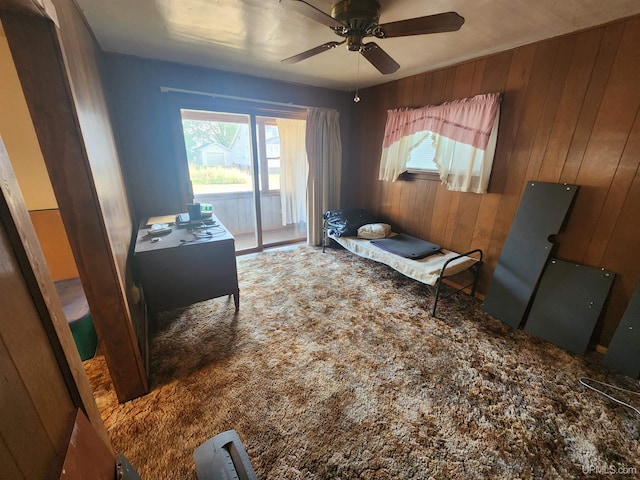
xmin=306 ymin=108 xmax=342 ymax=245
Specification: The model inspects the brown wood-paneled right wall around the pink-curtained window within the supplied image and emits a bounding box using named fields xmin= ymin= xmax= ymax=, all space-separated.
xmin=343 ymin=17 xmax=640 ymax=345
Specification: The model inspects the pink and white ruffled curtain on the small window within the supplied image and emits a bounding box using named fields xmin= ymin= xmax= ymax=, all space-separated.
xmin=379 ymin=93 xmax=501 ymax=193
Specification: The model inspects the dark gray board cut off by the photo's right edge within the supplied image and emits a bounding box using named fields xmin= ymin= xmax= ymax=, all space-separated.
xmin=604 ymin=284 xmax=640 ymax=378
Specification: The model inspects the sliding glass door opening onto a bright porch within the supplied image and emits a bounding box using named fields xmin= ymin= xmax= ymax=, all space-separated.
xmin=180 ymin=108 xmax=308 ymax=253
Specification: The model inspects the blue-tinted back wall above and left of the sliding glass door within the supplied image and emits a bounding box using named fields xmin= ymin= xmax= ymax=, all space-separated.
xmin=106 ymin=54 xmax=351 ymax=220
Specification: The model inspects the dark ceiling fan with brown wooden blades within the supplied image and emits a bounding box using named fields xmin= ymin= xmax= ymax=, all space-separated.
xmin=280 ymin=0 xmax=464 ymax=75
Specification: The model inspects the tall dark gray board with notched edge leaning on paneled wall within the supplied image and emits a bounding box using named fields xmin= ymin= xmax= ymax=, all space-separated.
xmin=483 ymin=182 xmax=578 ymax=328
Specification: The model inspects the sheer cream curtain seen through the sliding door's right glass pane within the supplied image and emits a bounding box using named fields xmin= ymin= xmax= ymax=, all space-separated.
xmin=276 ymin=118 xmax=309 ymax=225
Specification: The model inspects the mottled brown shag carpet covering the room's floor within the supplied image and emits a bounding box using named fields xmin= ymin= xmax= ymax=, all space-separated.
xmin=85 ymin=247 xmax=640 ymax=480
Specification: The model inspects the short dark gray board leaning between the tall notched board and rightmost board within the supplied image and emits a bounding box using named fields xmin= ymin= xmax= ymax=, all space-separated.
xmin=524 ymin=259 xmax=615 ymax=355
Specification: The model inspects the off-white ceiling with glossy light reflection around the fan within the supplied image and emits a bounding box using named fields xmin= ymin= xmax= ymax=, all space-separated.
xmin=75 ymin=0 xmax=640 ymax=90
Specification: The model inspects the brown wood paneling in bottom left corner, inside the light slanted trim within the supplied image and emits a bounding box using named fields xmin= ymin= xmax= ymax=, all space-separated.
xmin=0 ymin=181 xmax=80 ymax=479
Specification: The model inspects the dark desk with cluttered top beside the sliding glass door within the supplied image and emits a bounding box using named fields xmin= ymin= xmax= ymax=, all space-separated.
xmin=134 ymin=216 xmax=240 ymax=314
